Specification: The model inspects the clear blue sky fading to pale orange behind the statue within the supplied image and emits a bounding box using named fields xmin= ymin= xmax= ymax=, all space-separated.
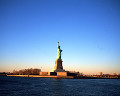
xmin=0 ymin=0 xmax=120 ymax=74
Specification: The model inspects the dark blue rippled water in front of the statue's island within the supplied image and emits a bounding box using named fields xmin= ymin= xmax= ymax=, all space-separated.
xmin=0 ymin=76 xmax=120 ymax=96
